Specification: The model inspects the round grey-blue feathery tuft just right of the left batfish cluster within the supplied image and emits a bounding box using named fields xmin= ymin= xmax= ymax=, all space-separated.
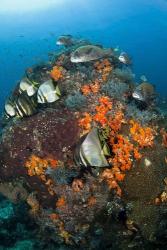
xmin=65 ymin=91 xmax=87 ymax=110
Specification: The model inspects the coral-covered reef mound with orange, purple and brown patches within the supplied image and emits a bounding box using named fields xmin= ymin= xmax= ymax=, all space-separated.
xmin=0 ymin=38 xmax=167 ymax=249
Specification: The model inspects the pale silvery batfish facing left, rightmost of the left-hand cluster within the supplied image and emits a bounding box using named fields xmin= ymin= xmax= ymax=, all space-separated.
xmin=37 ymin=79 xmax=61 ymax=103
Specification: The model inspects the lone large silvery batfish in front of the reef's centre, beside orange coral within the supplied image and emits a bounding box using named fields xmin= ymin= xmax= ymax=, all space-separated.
xmin=74 ymin=128 xmax=109 ymax=168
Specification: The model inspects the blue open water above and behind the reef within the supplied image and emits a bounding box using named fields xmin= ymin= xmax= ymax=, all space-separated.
xmin=0 ymin=0 xmax=167 ymax=113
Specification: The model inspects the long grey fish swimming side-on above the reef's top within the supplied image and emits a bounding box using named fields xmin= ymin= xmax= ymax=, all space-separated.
xmin=70 ymin=45 xmax=113 ymax=63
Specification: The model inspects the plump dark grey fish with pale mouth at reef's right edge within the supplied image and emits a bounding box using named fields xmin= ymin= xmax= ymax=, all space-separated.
xmin=132 ymin=82 xmax=156 ymax=103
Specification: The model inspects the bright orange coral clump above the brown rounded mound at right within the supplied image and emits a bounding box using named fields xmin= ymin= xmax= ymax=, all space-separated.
xmin=130 ymin=120 xmax=155 ymax=148
